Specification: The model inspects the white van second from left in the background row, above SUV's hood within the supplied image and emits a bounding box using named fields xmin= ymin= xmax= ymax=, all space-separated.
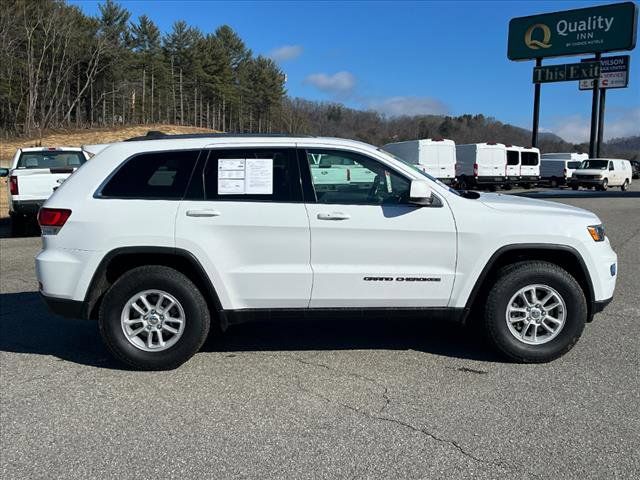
xmin=456 ymin=143 xmax=507 ymax=190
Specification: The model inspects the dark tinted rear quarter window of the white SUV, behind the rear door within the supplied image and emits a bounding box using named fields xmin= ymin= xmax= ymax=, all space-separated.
xmin=99 ymin=150 xmax=200 ymax=200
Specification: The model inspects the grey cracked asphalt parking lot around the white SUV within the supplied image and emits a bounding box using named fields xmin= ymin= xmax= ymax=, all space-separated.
xmin=0 ymin=185 xmax=640 ymax=479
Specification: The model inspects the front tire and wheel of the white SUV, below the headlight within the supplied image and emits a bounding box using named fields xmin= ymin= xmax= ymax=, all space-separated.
xmin=484 ymin=261 xmax=587 ymax=363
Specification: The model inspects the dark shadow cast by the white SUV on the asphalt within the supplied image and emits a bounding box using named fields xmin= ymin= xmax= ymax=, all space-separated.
xmin=0 ymin=292 xmax=504 ymax=369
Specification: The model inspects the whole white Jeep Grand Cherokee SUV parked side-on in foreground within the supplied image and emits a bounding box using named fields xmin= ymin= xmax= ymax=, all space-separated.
xmin=36 ymin=135 xmax=617 ymax=369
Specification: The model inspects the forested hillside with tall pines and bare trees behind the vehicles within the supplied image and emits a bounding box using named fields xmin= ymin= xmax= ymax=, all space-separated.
xmin=0 ymin=0 xmax=640 ymax=158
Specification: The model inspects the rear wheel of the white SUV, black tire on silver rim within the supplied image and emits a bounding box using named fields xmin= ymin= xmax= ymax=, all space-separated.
xmin=98 ymin=265 xmax=211 ymax=370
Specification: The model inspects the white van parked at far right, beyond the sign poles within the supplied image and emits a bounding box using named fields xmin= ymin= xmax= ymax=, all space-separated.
xmin=571 ymin=158 xmax=633 ymax=192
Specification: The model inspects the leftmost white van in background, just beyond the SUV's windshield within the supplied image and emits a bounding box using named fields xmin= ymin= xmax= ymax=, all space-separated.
xmin=382 ymin=138 xmax=456 ymax=184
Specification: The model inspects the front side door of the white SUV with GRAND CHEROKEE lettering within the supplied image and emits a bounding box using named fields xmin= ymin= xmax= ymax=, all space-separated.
xmin=300 ymin=148 xmax=457 ymax=308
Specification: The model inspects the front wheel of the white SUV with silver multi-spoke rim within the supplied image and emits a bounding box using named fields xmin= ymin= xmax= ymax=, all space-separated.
xmin=485 ymin=261 xmax=587 ymax=363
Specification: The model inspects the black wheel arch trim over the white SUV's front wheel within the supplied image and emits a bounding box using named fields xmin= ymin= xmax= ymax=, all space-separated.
xmin=462 ymin=243 xmax=595 ymax=323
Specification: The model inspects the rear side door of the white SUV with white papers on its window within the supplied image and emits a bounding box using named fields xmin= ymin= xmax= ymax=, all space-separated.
xmin=175 ymin=146 xmax=312 ymax=309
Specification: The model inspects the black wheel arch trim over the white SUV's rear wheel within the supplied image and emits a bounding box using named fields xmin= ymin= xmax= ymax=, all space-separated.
xmin=82 ymin=246 xmax=226 ymax=327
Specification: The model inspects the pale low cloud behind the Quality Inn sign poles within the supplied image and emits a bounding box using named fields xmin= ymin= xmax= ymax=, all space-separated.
xmin=547 ymin=107 xmax=640 ymax=143
